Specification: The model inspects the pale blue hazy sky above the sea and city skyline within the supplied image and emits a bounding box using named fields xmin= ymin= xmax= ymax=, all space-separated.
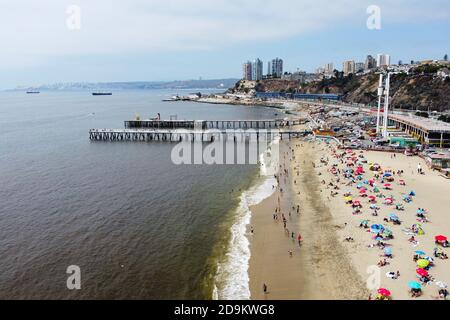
xmin=0 ymin=0 xmax=450 ymax=89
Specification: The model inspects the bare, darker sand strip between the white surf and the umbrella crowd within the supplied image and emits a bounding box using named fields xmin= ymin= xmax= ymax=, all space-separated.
xmin=249 ymin=140 xmax=368 ymax=300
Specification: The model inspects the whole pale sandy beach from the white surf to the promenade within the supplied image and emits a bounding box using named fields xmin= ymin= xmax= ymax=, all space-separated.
xmin=249 ymin=140 xmax=450 ymax=300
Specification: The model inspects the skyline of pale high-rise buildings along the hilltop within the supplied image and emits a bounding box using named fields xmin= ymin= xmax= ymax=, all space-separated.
xmin=242 ymin=53 xmax=449 ymax=83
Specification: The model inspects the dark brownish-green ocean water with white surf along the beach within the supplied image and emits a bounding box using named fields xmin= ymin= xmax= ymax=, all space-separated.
xmin=0 ymin=91 xmax=281 ymax=299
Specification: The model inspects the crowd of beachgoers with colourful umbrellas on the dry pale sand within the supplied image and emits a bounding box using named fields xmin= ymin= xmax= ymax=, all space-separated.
xmin=318 ymin=143 xmax=450 ymax=300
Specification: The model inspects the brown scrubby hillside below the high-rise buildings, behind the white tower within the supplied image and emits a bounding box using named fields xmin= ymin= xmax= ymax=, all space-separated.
xmin=231 ymin=66 xmax=450 ymax=111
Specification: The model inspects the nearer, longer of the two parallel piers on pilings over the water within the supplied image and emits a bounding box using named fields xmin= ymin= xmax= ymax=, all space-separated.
xmin=89 ymin=129 xmax=312 ymax=142
